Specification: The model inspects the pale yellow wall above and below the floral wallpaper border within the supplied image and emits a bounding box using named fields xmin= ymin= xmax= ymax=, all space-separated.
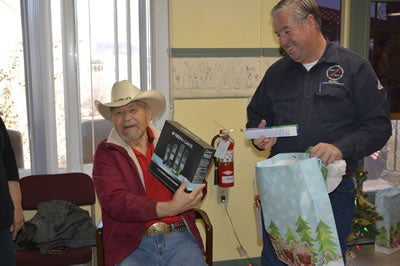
xmin=169 ymin=0 xmax=278 ymax=261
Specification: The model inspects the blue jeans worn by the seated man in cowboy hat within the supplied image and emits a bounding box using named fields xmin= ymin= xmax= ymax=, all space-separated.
xmin=116 ymin=230 xmax=206 ymax=266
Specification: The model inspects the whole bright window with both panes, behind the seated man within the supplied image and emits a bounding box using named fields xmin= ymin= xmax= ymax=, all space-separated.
xmin=0 ymin=0 xmax=168 ymax=173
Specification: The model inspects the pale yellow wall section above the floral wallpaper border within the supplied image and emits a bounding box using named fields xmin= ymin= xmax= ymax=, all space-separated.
xmin=169 ymin=0 xmax=278 ymax=48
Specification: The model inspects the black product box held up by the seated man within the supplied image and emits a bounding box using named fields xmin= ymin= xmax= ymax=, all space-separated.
xmin=149 ymin=120 xmax=215 ymax=192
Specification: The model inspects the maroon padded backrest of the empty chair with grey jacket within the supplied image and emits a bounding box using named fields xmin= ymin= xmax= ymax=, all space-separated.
xmin=20 ymin=173 xmax=96 ymax=210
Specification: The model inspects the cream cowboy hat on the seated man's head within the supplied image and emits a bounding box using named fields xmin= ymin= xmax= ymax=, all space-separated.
xmin=94 ymin=80 xmax=165 ymax=121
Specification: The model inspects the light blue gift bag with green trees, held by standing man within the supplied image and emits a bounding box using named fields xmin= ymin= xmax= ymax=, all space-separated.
xmin=256 ymin=153 xmax=344 ymax=265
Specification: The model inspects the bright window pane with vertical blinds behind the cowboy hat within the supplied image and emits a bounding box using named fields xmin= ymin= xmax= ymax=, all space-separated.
xmin=77 ymin=0 xmax=144 ymax=168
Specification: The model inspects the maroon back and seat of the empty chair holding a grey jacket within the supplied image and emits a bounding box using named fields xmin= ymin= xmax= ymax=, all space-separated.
xmin=16 ymin=173 xmax=97 ymax=266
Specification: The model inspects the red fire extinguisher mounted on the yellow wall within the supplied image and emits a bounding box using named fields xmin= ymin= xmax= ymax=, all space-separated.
xmin=211 ymin=129 xmax=235 ymax=187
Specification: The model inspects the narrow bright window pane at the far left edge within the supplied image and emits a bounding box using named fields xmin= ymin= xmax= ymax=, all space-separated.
xmin=0 ymin=0 xmax=30 ymax=168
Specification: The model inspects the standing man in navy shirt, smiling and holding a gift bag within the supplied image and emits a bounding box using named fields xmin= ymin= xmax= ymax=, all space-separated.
xmin=246 ymin=0 xmax=392 ymax=266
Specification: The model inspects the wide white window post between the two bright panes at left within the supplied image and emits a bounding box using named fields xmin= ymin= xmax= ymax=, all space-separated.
xmin=21 ymin=0 xmax=57 ymax=173
